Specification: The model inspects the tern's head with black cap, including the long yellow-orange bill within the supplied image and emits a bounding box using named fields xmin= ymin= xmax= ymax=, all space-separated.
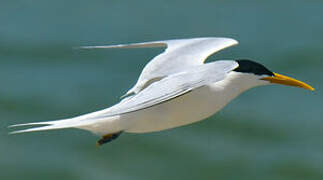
xmin=233 ymin=59 xmax=314 ymax=91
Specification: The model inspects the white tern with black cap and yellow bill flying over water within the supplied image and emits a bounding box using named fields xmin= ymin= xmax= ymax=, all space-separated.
xmin=10 ymin=37 xmax=314 ymax=145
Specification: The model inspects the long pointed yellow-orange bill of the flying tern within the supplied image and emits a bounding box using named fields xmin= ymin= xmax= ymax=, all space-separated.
xmin=262 ymin=73 xmax=315 ymax=91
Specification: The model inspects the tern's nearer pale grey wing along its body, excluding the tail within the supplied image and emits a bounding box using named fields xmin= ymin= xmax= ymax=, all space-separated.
xmin=95 ymin=61 xmax=238 ymax=118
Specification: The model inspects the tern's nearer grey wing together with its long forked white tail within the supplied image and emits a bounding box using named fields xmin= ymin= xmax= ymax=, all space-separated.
xmin=11 ymin=61 xmax=239 ymax=134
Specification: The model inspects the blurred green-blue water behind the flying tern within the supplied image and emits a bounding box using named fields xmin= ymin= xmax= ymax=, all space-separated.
xmin=0 ymin=0 xmax=323 ymax=180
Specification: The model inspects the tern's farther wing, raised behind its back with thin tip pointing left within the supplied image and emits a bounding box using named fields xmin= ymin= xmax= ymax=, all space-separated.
xmin=82 ymin=37 xmax=238 ymax=95
